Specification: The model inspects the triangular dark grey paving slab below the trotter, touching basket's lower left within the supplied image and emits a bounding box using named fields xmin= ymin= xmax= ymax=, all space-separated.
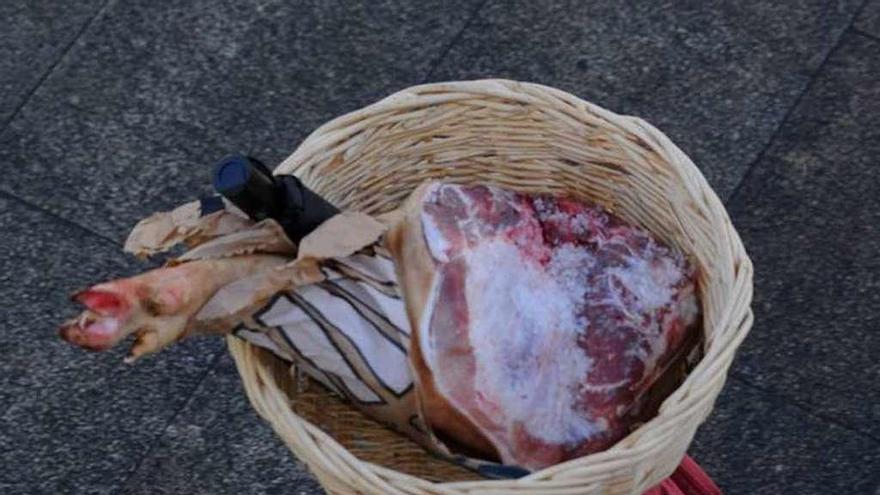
xmin=124 ymin=354 xmax=324 ymax=495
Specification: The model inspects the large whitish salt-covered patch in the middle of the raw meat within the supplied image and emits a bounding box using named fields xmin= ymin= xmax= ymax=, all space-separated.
xmin=468 ymin=242 xmax=599 ymax=443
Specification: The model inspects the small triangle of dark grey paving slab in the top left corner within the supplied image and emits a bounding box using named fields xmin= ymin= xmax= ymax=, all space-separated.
xmin=0 ymin=0 xmax=104 ymax=125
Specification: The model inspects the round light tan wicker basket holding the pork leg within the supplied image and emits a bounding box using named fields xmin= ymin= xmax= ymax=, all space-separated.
xmin=228 ymin=80 xmax=752 ymax=495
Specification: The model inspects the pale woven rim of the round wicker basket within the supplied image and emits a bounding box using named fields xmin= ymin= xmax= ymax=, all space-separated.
xmin=227 ymin=79 xmax=753 ymax=493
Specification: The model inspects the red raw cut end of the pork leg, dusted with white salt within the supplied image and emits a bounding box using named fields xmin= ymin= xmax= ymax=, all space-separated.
xmin=388 ymin=183 xmax=698 ymax=469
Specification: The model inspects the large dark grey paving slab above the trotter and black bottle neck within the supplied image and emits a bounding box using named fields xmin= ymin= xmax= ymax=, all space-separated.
xmin=0 ymin=0 xmax=476 ymax=242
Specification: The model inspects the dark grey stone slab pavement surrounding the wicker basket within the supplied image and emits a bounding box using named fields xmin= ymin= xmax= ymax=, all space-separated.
xmin=0 ymin=0 xmax=880 ymax=494
